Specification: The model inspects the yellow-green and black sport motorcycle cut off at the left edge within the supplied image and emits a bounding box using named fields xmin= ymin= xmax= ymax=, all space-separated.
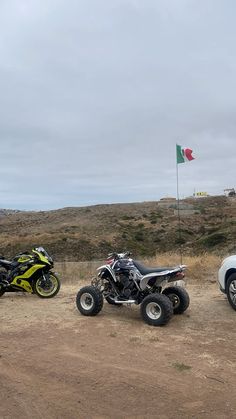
xmin=0 ymin=247 xmax=60 ymax=298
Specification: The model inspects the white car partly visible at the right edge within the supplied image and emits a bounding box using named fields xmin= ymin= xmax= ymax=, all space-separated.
xmin=218 ymin=255 xmax=236 ymax=310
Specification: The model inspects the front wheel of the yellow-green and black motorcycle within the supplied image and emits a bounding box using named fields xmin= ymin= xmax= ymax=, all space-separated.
xmin=33 ymin=272 xmax=61 ymax=298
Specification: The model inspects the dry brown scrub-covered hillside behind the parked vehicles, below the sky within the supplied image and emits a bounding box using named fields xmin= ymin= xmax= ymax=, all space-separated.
xmin=0 ymin=196 xmax=236 ymax=260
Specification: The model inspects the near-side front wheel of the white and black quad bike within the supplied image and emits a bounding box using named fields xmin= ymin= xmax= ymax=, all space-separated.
xmin=76 ymin=286 xmax=103 ymax=316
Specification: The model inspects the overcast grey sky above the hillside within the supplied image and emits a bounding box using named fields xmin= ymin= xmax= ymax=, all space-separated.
xmin=0 ymin=0 xmax=236 ymax=210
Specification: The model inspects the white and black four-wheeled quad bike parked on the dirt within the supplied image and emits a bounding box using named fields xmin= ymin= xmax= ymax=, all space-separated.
xmin=76 ymin=252 xmax=190 ymax=326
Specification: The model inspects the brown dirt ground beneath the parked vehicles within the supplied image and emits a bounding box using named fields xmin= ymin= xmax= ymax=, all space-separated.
xmin=0 ymin=284 xmax=236 ymax=419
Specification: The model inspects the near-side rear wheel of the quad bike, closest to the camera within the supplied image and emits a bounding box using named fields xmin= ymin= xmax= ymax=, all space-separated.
xmin=140 ymin=294 xmax=173 ymax=326
